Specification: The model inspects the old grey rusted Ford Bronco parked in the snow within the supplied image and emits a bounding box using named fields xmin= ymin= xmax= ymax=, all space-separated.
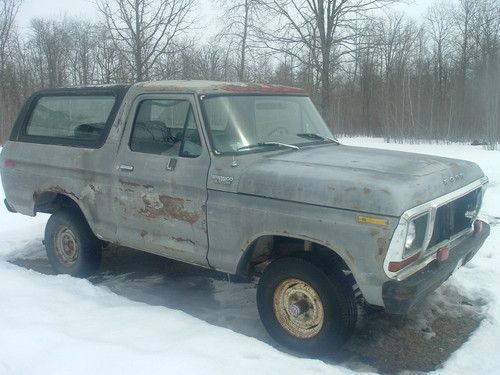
xmin=1 ymin=81 xmax=489 ymax=354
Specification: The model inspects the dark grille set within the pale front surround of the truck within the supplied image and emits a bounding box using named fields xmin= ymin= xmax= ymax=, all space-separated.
xmin=428 ymin=188 xmax=481 ymax=248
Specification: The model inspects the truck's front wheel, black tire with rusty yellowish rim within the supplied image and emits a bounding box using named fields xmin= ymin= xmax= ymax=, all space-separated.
xmin=257 ymin=257 xmax=357 ymax=355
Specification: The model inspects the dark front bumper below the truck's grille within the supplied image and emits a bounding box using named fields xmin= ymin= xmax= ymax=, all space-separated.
xmin=382 ymin=223 xmax=490 ymax=314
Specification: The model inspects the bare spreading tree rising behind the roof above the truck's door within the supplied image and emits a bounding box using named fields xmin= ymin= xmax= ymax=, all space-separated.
xmin=97 ymin=0 xmax=195 ymax=81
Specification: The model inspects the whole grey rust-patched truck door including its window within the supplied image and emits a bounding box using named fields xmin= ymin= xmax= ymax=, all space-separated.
xmin=113 ymin=94 xmax=210 ymax=265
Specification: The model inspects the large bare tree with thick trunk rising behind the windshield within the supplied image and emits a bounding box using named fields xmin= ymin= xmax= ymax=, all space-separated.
xmin=264 ymin=0 xmax=396 ymax=126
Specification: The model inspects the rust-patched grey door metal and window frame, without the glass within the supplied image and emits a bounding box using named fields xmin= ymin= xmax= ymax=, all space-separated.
xmin=113 ymin=94 xmax=210 ymax=265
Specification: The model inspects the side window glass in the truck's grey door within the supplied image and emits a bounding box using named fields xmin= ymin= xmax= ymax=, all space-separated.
xmin=130 ymin=99 xmax=201 ymax=157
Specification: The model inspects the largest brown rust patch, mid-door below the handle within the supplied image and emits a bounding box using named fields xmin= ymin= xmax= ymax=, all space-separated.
xmin=139 ymin=195 xmax=200 ymax=224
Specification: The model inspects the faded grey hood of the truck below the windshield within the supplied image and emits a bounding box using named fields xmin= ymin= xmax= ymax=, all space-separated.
xmin=236 ymin=145 xmax=484 ymax=216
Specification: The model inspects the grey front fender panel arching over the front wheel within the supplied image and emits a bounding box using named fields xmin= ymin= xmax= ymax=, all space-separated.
xmin=207 ymin=190 xmax=398 ymax=305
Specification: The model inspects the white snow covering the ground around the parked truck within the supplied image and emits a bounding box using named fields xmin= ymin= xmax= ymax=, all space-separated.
xmin=0 ymin=138 xmax=500 ymax=375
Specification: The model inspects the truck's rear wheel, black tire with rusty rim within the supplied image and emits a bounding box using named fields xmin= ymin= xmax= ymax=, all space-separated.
xmin=45 ymin=210 xmax=102 ymax=277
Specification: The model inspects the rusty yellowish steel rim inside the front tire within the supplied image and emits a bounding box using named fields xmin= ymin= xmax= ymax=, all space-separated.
xmin=273 ymin=279 xmax=325 ymax=339
